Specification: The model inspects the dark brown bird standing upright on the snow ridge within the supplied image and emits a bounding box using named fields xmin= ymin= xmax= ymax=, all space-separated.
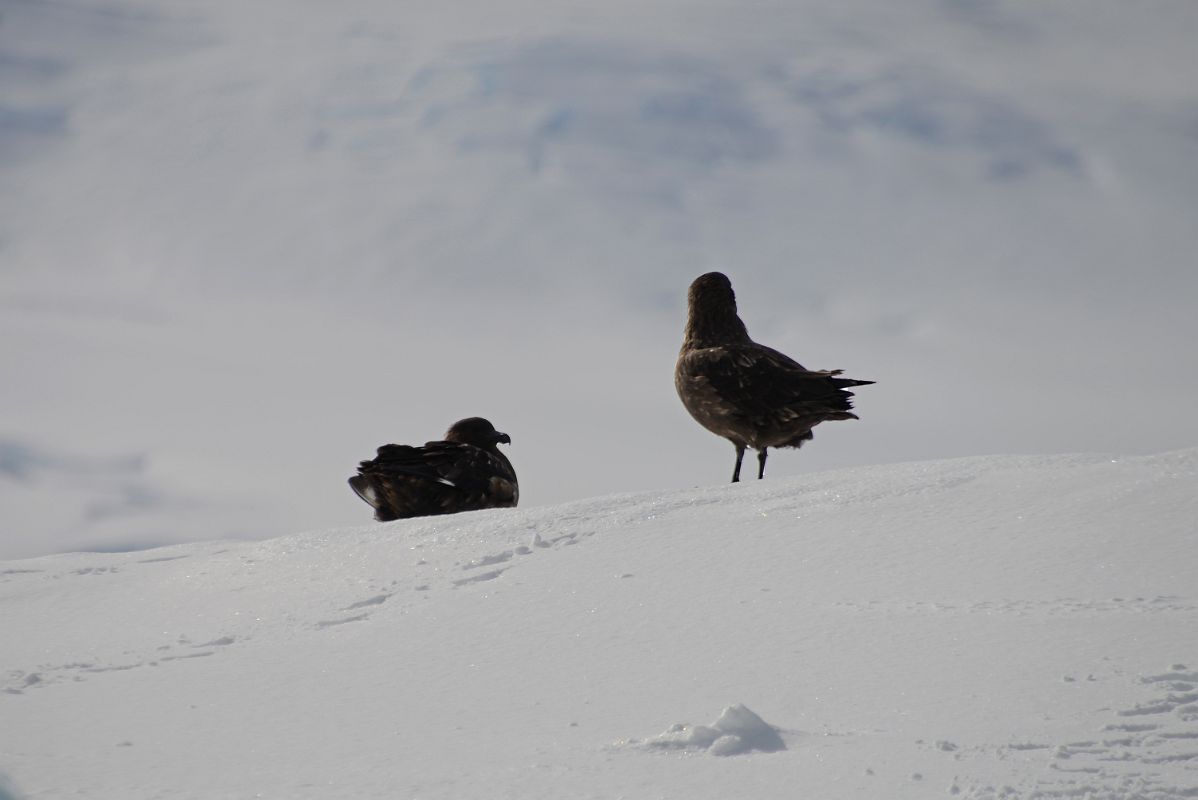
xmin=674 ymin=272 xmax=873 ymax=483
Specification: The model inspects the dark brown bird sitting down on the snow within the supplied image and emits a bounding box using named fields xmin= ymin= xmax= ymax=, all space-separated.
xmin=350 ymin=417 xmax=520 ymax=522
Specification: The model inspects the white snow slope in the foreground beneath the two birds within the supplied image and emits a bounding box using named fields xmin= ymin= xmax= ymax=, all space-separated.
xmin=0 ymin=449 xmax=1198 ymax=800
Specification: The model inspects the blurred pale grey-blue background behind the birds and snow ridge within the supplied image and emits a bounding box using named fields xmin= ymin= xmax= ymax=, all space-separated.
xmin=0 ymin=0 xmax=1198 ymax=558
